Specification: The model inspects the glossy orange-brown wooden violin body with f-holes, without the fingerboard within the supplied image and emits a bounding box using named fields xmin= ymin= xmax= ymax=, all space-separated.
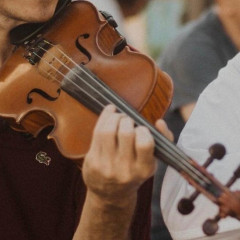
xmin=0 ymin=1 xmax=172 ymax=159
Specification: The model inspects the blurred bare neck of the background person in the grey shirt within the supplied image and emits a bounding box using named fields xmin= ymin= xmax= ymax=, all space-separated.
xmin=216 ymin=7 xmax=240 ymax=50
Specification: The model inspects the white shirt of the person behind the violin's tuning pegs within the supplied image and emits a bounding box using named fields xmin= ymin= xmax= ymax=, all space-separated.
xmin=161 ymin=51 xmax=240 ymax=240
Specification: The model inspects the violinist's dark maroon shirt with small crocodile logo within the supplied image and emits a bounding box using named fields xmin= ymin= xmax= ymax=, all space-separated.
xmin=0 ymin=123 xmax=152 ymax=240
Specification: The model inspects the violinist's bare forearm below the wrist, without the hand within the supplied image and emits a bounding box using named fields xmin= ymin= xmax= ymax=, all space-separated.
xmin=73 ymin=192 xmax=136 ymax=240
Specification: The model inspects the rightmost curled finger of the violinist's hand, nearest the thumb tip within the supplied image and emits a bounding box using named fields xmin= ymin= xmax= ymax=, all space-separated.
xmin=135 ymin=126 xmax=154 ymax=163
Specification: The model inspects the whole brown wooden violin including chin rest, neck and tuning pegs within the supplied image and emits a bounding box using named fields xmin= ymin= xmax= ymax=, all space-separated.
xmin=0 ymin=0 xmax=240 ymax=235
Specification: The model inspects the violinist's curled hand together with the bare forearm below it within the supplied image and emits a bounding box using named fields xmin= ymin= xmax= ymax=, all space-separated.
xmin=73 ymin=105 xmax=156 ymax=240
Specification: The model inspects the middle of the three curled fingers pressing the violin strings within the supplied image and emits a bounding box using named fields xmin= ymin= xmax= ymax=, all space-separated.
xmin=118 ymin=117 xmax=135 ymax=160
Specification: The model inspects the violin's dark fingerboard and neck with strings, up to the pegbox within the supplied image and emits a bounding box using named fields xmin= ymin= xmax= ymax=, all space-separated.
xmin=61 ymin=65 xmax=222 ymax=200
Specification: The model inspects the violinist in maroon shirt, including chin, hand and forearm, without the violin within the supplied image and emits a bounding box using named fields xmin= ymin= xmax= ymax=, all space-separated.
xmin=0 ymin=0 xmax=171 ymax=240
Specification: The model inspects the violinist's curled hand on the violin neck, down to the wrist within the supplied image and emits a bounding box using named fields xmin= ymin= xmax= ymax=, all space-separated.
xmin=82 ymin=105 xmax=156 ymax=204
